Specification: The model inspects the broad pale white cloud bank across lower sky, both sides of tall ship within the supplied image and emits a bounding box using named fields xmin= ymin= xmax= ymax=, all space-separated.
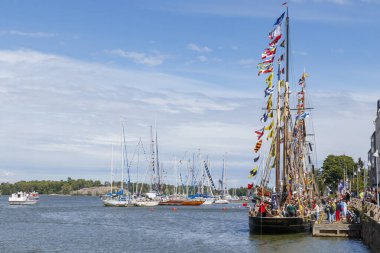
xmin=0 ymin=50 xmax=379 ymax=185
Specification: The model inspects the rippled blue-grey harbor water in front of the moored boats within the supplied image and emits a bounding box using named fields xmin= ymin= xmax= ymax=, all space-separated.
xmin=0 ymin=196 xmax=370 ymax=253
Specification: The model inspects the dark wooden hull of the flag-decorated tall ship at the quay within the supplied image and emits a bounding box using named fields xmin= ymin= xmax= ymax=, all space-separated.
xmin=249 ymin=216 xmax=312 ymax=234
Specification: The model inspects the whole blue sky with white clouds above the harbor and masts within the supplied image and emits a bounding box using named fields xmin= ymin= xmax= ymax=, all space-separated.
xmin=0 ymin=0 xmax=380 ymax=186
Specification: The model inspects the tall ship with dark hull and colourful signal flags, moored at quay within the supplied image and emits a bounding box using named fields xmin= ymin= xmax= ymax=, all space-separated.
xmin=248 ymin=6 xmax=318 ymax=234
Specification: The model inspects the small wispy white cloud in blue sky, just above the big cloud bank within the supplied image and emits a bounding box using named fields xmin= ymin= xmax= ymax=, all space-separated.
xmin=110 ymin=49 xmax=167 ymax=66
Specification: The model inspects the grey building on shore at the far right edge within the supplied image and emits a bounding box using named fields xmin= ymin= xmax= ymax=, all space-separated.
xmin=368 ymin=99 xmax=380 ymax=187
